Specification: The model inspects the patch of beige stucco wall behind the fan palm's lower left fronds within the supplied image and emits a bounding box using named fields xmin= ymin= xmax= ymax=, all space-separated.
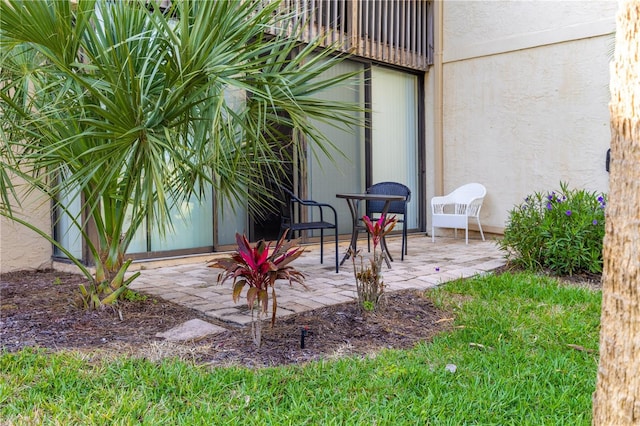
xmin=0 ymin=180 xmax=52 ymax=273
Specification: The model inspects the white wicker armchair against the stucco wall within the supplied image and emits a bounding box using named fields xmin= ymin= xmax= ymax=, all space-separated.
xmin=431 ymin=183 xmax=487 ymax=244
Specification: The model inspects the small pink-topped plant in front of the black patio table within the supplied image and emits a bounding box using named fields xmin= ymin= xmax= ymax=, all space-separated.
xmin=351 ymin=215 xmax=398 ymax=311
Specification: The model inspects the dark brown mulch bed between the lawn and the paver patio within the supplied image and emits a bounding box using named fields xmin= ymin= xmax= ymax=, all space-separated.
xmin=0 ymin=270 xmax=452 ymax=367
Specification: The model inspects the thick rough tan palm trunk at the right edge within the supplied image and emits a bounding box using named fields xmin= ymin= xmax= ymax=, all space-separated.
xmin=593 ymin=0 xmax=640 ymax=425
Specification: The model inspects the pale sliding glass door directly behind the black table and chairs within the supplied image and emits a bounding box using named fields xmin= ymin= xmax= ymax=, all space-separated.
xmin=303 ymin=62 xmax=420 ymax=233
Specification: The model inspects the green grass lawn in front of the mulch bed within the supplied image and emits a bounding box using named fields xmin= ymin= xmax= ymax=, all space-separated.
xmin=0 ymin=273 xmax=601 ymax=425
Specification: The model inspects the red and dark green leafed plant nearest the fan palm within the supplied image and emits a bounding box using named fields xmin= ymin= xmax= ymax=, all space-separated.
xmin=208 ymin=232 xmax=304 ymax=346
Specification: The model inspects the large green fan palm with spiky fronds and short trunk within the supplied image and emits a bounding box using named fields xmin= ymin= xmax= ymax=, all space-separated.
xmin=0 ymin=0 xmax=359 ymax=306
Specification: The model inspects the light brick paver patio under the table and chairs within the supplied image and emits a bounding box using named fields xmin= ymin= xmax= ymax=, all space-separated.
xmin=126 ymin=234 xmax=505 ymax=325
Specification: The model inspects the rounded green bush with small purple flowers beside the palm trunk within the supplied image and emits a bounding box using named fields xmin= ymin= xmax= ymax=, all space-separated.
xmin=499 ymin=182 xmax=607 ymax=275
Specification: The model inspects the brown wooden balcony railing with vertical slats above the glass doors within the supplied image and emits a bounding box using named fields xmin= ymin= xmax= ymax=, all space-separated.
xmin=266 ymin=0 xmax=433 ymax=71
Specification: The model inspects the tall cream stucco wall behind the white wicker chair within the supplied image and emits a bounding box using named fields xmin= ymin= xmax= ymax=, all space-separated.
xmin=426 ymin=1 xmax=617 ymax=230
